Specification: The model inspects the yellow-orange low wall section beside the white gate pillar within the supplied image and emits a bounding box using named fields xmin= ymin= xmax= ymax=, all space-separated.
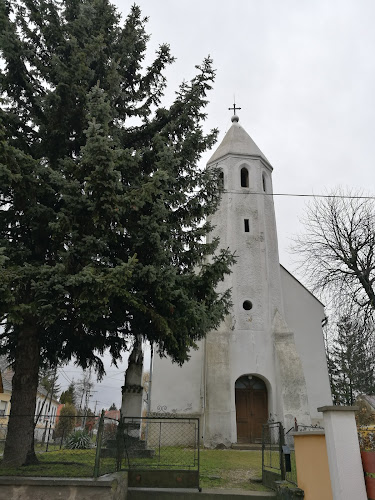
xmin=294 ymin=433 xmax=334 ymax=500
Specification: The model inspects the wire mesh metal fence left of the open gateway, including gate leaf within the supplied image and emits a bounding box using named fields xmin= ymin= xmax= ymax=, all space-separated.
xmin=0 ymin=411 xmax=199 ymax=487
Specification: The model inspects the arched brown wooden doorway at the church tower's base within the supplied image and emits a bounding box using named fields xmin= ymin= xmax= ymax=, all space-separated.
xmin=235 ymin=375 xmax=268 ymax=443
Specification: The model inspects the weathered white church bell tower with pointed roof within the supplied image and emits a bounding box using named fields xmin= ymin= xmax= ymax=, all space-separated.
xmin=205 ymin=115 xmax=310 ymax=445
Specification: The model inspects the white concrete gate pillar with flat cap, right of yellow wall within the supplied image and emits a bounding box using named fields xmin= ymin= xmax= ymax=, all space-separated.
xmin=318 ymin=406 xmax=367 ymax=500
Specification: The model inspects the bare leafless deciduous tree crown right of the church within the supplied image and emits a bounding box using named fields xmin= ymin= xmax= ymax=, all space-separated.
xmin=293 ymin=190 xmax=375 ymax=316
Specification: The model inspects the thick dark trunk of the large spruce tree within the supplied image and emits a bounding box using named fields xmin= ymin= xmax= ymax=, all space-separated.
xmin=3 ymin=324 xmax=40 ymax=467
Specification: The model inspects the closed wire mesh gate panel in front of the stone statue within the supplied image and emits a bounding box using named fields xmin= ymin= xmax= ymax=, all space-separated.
xmin=101 ymin=417 xmax=200 ymax=489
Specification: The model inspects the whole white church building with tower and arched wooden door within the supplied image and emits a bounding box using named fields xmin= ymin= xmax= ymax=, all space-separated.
xmin=150 ymin=115 xmax=332 ymax=447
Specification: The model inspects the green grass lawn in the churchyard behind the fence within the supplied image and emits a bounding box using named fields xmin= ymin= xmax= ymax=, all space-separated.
xmin=0 ymin=447 xmax=267 ymax=491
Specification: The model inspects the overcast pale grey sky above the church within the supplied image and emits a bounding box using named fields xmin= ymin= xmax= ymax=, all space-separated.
xmin=58 ymin=0 xmax=375 ymax=406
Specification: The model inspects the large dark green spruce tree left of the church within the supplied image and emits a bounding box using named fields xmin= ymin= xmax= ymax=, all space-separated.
xmin=0 ymin=0 xmax=233 ymax=465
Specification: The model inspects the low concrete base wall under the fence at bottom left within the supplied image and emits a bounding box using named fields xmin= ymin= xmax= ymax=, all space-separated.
xmin=0 ymin=472 xmax=128 ymax=500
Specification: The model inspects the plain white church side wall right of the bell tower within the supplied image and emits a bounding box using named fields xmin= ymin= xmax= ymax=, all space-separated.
xmin=280 ymin=266 xmax=332 ymax=424
